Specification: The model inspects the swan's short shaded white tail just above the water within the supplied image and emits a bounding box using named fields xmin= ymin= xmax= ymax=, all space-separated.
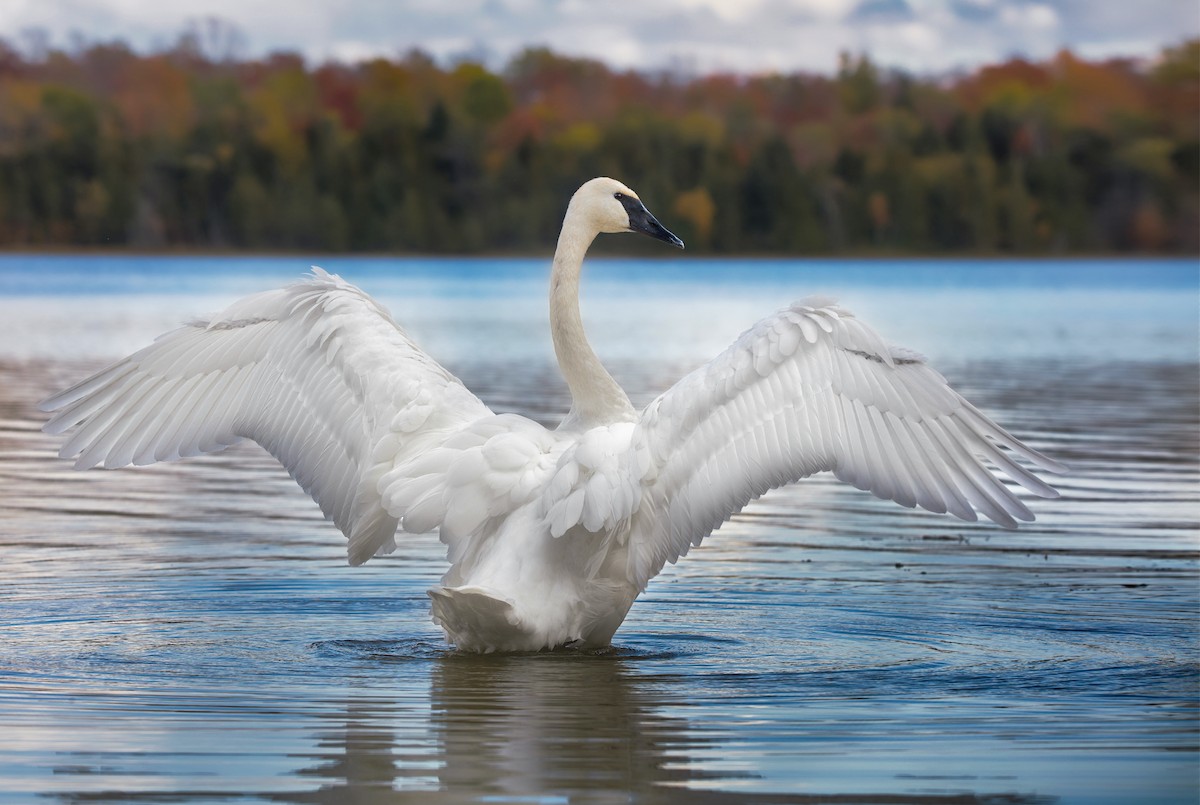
xmin=428 ymin=587 xmax=530 ymax=654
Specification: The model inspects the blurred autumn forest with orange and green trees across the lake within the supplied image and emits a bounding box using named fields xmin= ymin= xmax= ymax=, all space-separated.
xmin=0 ymin=34 xmax=1200 ymax=256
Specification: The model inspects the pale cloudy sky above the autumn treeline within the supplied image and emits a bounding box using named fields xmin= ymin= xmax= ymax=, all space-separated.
xmin=0 ymin=0 xmax=1200 ymax=73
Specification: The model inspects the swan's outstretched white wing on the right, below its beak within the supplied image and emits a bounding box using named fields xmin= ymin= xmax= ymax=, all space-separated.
xmin=630 ymin=300 xmax=1063 ymax=587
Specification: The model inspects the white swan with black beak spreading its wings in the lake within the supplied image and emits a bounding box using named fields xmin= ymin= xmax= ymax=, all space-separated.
xmin=41 ymin=178 xmax=1063 ymax=651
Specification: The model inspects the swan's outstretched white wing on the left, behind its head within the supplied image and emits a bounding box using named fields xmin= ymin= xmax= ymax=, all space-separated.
xmin=41 ymin=268 xmax=491 ymax=564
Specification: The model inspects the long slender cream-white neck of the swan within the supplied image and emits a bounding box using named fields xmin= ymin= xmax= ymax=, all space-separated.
xmin=550 ymin=214 xmax=635 ymax=427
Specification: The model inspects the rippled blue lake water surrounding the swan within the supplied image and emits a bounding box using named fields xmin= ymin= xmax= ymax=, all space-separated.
xmin=0 ymin=254 xmax=1200 ymax=804
